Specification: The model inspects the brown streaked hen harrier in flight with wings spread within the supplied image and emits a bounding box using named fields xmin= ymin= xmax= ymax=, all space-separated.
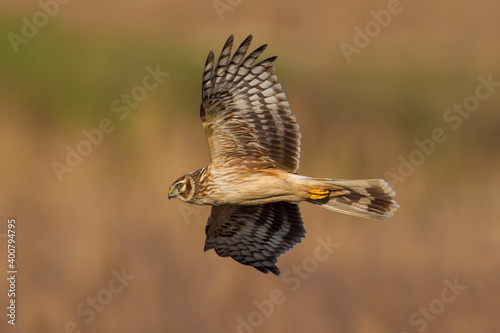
xmin=168 ymin=35 xmax=399 ymax=275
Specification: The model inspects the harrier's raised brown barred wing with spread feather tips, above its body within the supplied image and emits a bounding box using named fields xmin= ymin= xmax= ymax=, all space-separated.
xmin=200 ymin=35 xmax=300 ymax=172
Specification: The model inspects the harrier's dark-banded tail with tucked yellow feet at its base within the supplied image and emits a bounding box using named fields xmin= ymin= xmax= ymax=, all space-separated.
xmin=307 ymin=179 xmax=399 ymax=220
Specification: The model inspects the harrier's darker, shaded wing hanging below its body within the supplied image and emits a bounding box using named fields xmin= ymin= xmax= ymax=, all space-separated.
xmin=205 ymin=202 xmax=305 ymax=275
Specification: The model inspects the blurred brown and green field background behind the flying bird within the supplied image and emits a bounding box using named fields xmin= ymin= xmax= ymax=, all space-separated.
xmin=0 ymin=0 xmax=500 ymax=333
